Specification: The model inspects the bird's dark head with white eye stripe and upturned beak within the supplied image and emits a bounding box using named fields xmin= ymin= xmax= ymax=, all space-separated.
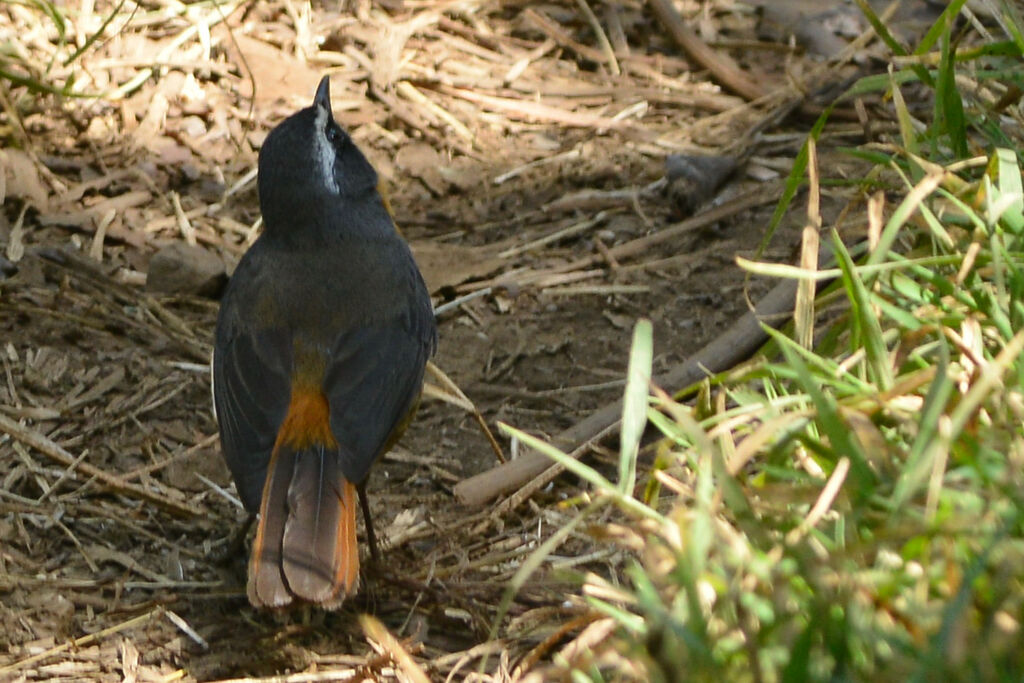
xmin=258 ymin=76 xmax=377 ymax=232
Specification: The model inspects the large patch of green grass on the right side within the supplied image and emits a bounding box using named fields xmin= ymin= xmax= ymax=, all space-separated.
xmin=507 ymin=2 xmax=1024 ymax=681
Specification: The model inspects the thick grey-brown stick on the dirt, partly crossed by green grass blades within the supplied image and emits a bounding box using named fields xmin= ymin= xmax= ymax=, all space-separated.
xmin=454 ymin=280 xmax=799 ymax=506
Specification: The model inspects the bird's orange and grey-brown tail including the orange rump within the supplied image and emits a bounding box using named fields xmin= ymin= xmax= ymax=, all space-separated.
xmin=248 ymin=388 xmax=359 ymax=609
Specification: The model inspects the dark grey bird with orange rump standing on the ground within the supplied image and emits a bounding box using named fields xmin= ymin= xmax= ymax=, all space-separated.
xmin=212 ymin=76 xmax=437 ymax=609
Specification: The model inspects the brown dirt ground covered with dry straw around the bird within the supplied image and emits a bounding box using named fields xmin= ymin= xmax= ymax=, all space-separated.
xmin=0 ymin=2 xmax=937 ymax=680
